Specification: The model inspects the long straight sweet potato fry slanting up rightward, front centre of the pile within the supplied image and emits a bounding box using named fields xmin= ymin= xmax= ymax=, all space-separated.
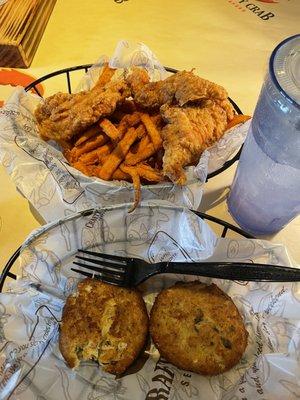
xmin=98 ymin=128 xmax=137 ymax=181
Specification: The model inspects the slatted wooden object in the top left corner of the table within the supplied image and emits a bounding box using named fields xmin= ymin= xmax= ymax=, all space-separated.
xmin=0 ymin=0 xmax=56 ymax=68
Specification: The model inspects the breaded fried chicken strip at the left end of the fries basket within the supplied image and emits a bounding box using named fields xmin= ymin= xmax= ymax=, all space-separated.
xmin=35 ymin=80 xmax=129 ymax=140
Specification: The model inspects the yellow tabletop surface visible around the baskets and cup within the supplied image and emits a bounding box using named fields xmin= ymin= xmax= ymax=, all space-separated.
xmin=0 ymin=0 xmax=300 ymax=280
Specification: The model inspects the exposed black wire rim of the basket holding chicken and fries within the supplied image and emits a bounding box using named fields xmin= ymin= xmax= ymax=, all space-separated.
xmin=25 ymin=64 xmax=243 ymax=180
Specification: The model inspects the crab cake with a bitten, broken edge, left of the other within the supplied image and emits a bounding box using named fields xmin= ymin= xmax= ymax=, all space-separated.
xmin=59 ymin=279 xmax=149 ymax=375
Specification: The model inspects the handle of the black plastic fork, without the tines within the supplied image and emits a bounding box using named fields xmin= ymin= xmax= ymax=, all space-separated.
xmin=160 ymin=262 xmax=300 ymax=282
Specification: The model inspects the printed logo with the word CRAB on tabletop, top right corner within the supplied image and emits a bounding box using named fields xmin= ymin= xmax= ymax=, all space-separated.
xmin=227 ymin=0 xmax=289 ymax=21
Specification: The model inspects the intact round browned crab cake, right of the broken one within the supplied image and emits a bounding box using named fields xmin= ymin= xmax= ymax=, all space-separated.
xmin=150 ymin=281 xmax=248 ymax=375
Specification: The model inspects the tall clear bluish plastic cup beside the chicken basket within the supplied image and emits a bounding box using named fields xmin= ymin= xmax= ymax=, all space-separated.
xmin=227 ymin=34 xmax=300 ymax=236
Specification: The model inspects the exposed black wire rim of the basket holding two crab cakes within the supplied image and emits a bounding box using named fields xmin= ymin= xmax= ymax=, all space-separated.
xmin=0 ymin=210 xmax=255 ymax=293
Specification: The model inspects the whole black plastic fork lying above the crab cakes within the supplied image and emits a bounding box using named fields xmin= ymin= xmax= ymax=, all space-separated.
xmin=71 ymin=250 xmax=300 ymax=286
